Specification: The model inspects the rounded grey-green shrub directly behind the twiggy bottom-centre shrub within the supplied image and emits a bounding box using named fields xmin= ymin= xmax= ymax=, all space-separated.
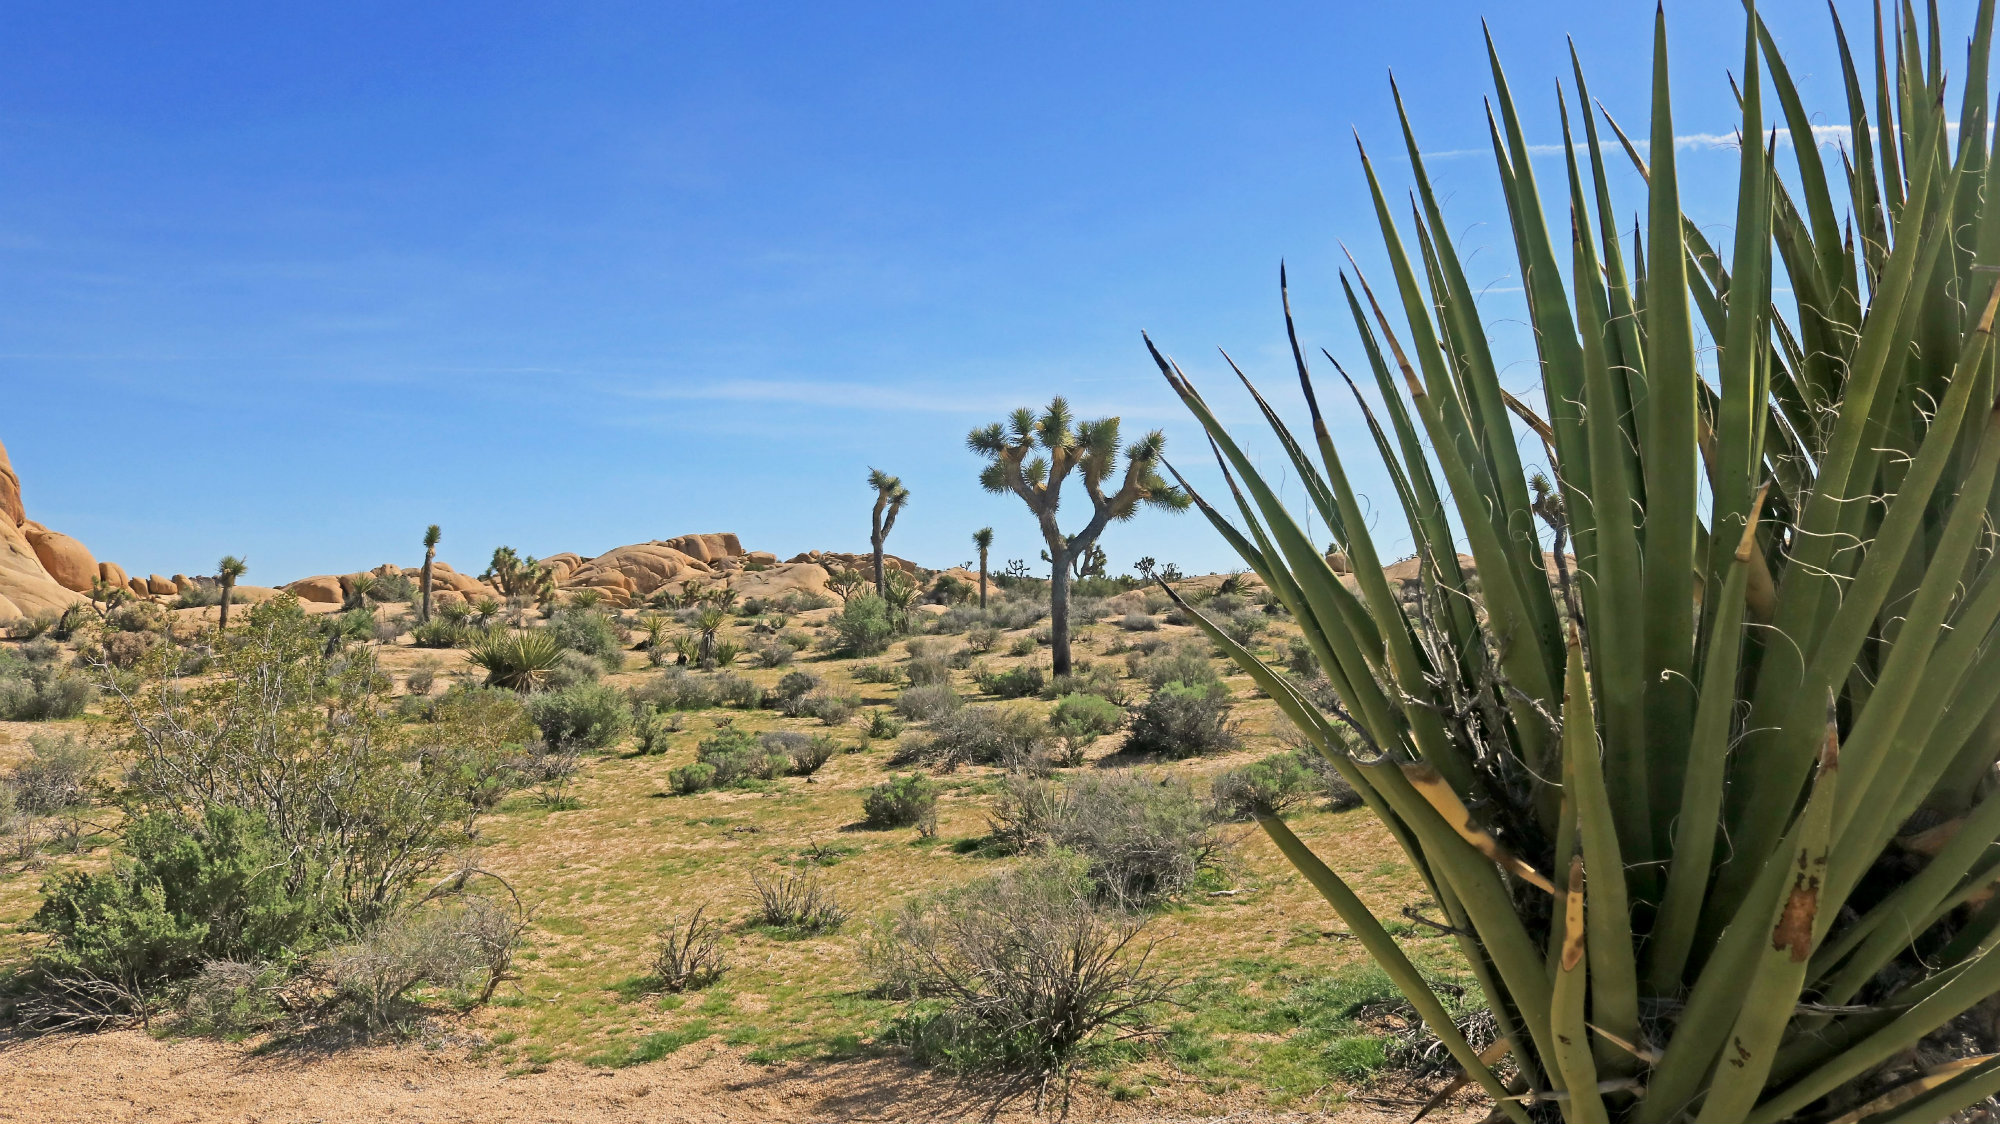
xmin=1048 ymin=770 xmax=1224 ymax=908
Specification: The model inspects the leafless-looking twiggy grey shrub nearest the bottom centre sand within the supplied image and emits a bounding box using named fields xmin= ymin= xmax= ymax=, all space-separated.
xmin=868 ymin=860 xmax=1172 ymax=1074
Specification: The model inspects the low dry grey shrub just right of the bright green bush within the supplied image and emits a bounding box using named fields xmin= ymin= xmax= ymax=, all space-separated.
xmin=314 ymin=894 xmax=520 ymax=1030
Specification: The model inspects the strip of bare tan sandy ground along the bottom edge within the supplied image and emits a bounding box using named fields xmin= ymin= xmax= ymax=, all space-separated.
xmin=0 ymin=1030 xmax=1480 ymax=1124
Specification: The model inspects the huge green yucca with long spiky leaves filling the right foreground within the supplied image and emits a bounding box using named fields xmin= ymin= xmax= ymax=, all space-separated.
xmin=1148 ymin=0 xmax=2000 ymax=1124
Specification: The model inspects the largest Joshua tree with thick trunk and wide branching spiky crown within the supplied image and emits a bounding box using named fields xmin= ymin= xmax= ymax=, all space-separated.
xmin=966 ymin=396 xmax=1190 ymax=676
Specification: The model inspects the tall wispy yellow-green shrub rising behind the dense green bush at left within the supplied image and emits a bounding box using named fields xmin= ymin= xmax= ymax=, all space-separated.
xmin=110 ymin=596 xmax=524 ymax=932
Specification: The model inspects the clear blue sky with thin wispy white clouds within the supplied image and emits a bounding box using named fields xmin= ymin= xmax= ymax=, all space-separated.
xmin=0 ymin=0 xmax=1970 ymax=582
